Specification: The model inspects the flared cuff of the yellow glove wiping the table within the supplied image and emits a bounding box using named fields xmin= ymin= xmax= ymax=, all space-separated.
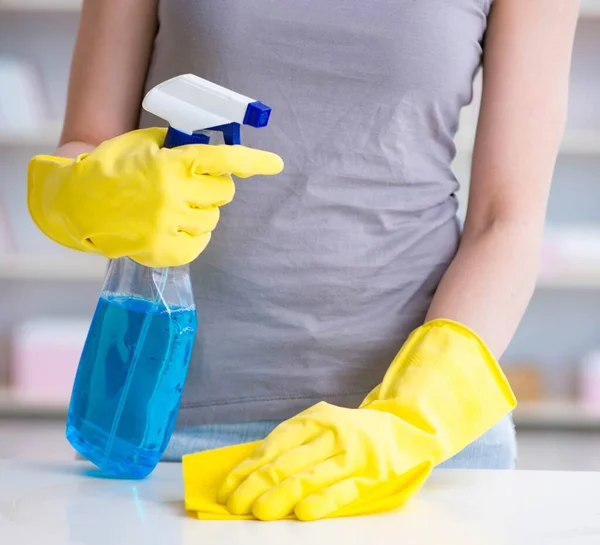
xmin=360 ymin=319 xmax=516 ymax=464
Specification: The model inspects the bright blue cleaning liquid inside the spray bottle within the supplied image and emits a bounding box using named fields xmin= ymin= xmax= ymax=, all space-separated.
xmin=67 ymin=294 xmax=197 ymax=479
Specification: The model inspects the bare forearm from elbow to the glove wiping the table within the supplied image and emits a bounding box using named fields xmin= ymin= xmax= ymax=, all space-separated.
xmin=427 ymin=220 xmax=541 ymax=358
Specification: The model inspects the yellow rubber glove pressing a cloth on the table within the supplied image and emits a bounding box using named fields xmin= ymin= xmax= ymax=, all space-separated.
xmin=206 ymin=320 xmax=516 ymax=520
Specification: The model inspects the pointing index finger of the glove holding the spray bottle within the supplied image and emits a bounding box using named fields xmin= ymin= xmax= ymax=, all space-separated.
xmin=171 ymin=144 xmax=283 ymax=178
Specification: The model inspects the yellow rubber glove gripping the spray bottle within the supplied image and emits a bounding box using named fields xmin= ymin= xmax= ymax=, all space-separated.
xmin=28 ymin=128 xmax=283 ymax=267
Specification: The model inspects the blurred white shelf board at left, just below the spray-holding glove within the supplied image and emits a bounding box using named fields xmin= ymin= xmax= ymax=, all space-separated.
xmin=0 ymin=254 xmax=107 ymax=281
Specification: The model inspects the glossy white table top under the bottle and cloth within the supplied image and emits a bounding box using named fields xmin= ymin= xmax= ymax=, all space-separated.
xmin=0 ymin=461 xmax=600 ymax=545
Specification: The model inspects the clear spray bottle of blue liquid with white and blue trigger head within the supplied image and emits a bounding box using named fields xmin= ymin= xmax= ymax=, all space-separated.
xmin=67 ymin=74 xmax=271 ymax=479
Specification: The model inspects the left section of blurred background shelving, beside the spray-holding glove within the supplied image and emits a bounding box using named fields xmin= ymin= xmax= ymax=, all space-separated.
xmin=0 ymin=0 xmax=95 ymax=419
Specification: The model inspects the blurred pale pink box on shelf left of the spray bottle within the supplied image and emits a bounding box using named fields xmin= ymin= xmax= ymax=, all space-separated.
xmin=11 ymin=319 xmax=89 ymax=404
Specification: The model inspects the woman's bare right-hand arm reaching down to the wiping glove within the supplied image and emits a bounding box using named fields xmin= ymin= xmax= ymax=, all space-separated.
xmin=427 ymin=0 xmax=579 ymax=358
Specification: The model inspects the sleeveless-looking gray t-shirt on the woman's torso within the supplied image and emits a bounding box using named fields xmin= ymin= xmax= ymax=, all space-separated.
xmin=141 ymin=0 xmax=491 ymax=426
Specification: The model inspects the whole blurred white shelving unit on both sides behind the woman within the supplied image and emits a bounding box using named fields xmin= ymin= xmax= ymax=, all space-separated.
xmin=0 ymin=4 xmax=600 ymax=431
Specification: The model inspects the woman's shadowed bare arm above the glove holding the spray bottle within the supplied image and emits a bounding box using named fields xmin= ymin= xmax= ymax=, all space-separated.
xmin=57 ymin=0 xmax=157 ymax=157
